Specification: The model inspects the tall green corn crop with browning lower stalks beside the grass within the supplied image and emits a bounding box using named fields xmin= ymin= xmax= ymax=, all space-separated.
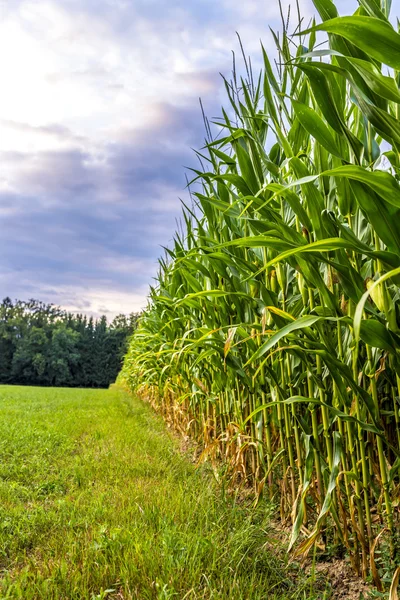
xmin=121 ymin=0 xmax=400 ymax=598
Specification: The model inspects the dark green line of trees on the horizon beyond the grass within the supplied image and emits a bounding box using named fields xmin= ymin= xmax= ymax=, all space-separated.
xmin=0 ymin=297 xmax=138 ymax=388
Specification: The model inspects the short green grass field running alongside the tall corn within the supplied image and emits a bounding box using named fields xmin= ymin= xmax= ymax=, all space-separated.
xmin=0 ymin=386 xmax=308 ymax=600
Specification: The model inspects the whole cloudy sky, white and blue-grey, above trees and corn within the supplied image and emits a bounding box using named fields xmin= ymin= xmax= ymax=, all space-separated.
xmin=0 ymin=0 xmax=362 ymax=318
